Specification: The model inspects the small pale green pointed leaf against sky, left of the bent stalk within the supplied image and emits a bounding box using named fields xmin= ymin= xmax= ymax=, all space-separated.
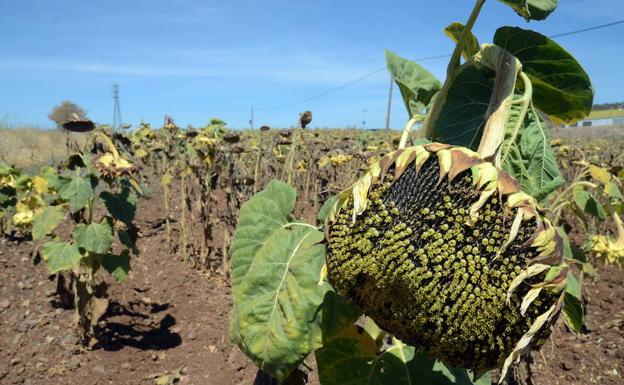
xmin=386 ymin=50 xmax=442 ymax=118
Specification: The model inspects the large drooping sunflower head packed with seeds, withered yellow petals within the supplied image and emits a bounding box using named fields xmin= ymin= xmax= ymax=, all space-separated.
xmin=326 ymin=143 xmax=566 ymax=375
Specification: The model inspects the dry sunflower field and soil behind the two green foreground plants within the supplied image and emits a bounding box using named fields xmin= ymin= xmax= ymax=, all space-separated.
xmin=0 ymin=125 xmax=624 ymax=384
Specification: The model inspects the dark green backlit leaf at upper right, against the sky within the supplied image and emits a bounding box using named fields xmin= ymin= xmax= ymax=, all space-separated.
xmin=494 ymin=27 xmax=594 ymax=123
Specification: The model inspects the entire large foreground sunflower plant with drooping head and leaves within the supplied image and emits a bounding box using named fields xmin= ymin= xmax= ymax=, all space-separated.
xmin=230 ymin=0 xmax=604 ymax=385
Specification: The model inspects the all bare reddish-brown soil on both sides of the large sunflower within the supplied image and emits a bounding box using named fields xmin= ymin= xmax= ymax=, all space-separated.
xmin=0 ymin=187 xmax=624 ymax=385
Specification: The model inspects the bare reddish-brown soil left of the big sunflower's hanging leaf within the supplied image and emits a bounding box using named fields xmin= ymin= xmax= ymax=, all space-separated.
xmin=0 ymin=190 xmax=256 ymax=385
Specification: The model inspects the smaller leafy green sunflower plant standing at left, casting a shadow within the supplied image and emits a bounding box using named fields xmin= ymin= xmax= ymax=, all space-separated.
xmin=32 ymin=129 xmax=141 ymax=345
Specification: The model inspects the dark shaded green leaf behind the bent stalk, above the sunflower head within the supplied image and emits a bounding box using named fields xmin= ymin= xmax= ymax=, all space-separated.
xmin=428 ymin=62 xmax=494 ymax=151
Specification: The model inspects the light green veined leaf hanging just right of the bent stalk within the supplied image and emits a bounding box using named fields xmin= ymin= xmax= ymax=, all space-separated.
xmin=500 ymin=103 xmax=565 ymax=201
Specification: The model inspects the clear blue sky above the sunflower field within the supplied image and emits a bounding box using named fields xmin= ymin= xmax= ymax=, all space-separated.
xmin=0 ymin=0 xmax=624 ymax=127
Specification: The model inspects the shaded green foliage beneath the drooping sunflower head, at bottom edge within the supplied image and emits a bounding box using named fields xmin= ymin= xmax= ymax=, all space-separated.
xmin=316 ymin=325 xmax=491 ymax=385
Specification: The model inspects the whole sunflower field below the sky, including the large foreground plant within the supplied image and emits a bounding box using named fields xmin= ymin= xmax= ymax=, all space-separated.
xmin=0 ymin=0 xmax=624 ymax=385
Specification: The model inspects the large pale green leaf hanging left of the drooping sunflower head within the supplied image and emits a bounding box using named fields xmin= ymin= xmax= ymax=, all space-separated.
xmin=230 ymin=181 xmax=328 ymax=381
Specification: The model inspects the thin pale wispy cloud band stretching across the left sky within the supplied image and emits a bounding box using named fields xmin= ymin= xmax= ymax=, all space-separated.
xmin=0 ymin=46 xmax=392 ymax=85
